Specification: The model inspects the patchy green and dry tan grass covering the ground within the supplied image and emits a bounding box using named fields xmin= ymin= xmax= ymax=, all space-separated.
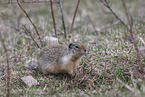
xmin=0 ymin=0 xmax=145 ymax=97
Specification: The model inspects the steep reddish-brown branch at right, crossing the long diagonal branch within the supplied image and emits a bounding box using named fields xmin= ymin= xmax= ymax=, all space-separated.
xmin=121 ymin=0 xmax=142 ymax=65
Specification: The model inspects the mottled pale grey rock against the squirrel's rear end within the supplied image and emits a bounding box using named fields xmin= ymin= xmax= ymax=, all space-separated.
xmin=26 ymin=59 xmax=38 ymax=70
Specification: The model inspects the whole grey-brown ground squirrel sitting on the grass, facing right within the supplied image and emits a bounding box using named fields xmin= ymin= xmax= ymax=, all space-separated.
xmin=37 ymin=42 xmax=86 ymax=75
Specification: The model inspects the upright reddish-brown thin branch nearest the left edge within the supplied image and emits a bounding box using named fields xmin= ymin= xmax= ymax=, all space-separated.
xmin=0 ymin=32 xmax=10 ymax=97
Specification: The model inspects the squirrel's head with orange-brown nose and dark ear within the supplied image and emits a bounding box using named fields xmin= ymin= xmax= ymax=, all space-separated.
xmin=68 ymin=42 xmax=86 ymax=58
